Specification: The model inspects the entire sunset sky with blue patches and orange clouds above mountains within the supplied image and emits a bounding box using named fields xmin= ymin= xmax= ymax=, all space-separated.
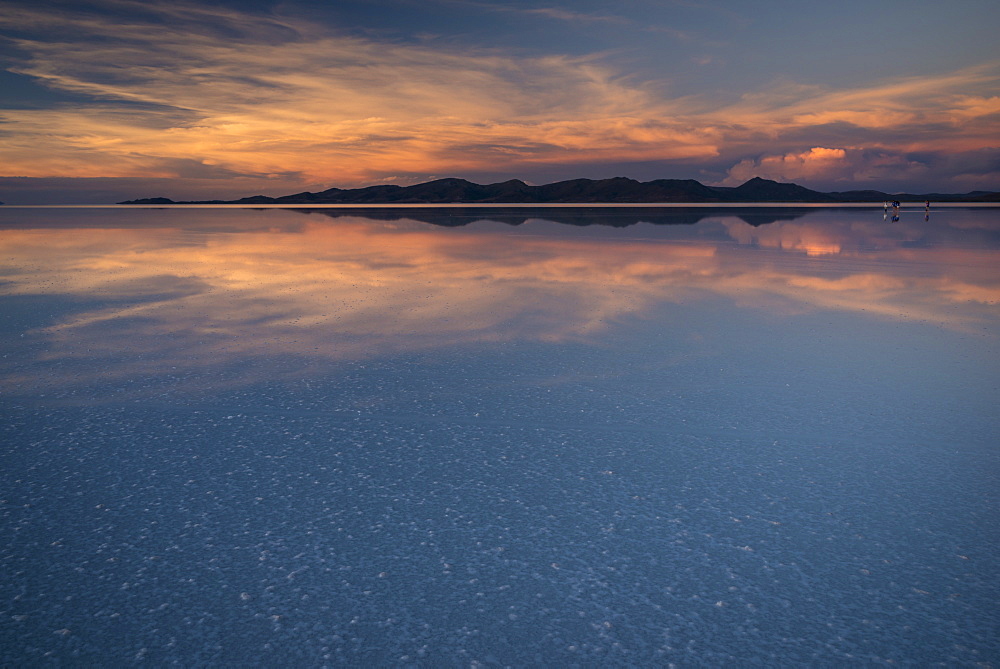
xmin=0 ymin=0 xmax=1000 ymax=204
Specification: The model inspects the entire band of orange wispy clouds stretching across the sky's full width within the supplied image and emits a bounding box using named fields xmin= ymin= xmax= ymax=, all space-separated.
xmin=0 ymin=0 xmax=1000 ymax=192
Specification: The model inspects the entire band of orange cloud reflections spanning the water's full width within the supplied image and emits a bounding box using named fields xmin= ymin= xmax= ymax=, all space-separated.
xmin=0 ymin=215 xmax=1000 ymax=392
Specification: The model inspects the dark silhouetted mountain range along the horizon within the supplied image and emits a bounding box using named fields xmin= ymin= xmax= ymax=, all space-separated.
xmin=118 ymin=177 xmax=1000 ymax=205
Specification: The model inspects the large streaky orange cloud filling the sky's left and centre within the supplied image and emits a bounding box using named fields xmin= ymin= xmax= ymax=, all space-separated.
xmin=0 ymin=8 xmax=716 ymax=183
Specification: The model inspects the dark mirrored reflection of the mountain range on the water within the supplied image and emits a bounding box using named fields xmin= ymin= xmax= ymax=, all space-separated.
xmin=289 ymin=207 xmax=815 ymax=228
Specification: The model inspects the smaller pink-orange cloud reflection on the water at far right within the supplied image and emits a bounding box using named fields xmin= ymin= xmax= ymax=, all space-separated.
xmin=725 ymin=219 xmax=1000 ymax=324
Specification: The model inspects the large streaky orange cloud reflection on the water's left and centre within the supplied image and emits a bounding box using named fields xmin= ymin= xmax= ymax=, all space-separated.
xmin=3 ymin=219 xmax=713 ymax=380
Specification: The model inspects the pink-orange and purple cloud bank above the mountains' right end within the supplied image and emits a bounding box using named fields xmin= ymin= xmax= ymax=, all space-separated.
xmin=717 ymin=64 xmax=1000 ymax=189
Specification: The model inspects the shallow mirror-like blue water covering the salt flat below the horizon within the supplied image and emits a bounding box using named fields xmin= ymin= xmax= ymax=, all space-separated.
xmin=0 ymin=207 xmax=1000 ymax=667
